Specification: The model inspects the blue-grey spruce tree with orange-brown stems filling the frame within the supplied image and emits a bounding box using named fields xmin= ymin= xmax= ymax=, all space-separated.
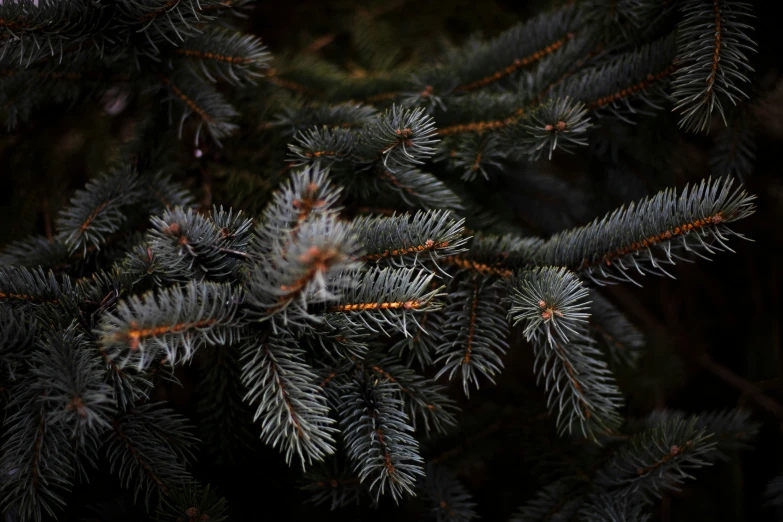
xmin=0 ymin=0 xmax=783 ymax=522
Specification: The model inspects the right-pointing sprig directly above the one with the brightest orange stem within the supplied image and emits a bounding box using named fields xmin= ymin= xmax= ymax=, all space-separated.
xmin=358 ymin=210 xmax=467 ymax=266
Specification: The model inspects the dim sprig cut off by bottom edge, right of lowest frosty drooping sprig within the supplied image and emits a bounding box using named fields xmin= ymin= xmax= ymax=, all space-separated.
xmin=417 ymin=463 xmax=479 ymax=522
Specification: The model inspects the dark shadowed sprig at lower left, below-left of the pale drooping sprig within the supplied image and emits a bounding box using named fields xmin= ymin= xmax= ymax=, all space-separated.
xmin=106 ymin=404 xmax=196 ymax=506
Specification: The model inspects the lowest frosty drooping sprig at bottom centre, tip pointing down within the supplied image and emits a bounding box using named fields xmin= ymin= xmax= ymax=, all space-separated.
xmin=340 ymin=378 xmax=424 ymax=502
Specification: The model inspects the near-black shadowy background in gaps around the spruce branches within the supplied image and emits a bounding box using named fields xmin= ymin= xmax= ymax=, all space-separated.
xmin=0 ymin=0 xmax=783 ymax=522
